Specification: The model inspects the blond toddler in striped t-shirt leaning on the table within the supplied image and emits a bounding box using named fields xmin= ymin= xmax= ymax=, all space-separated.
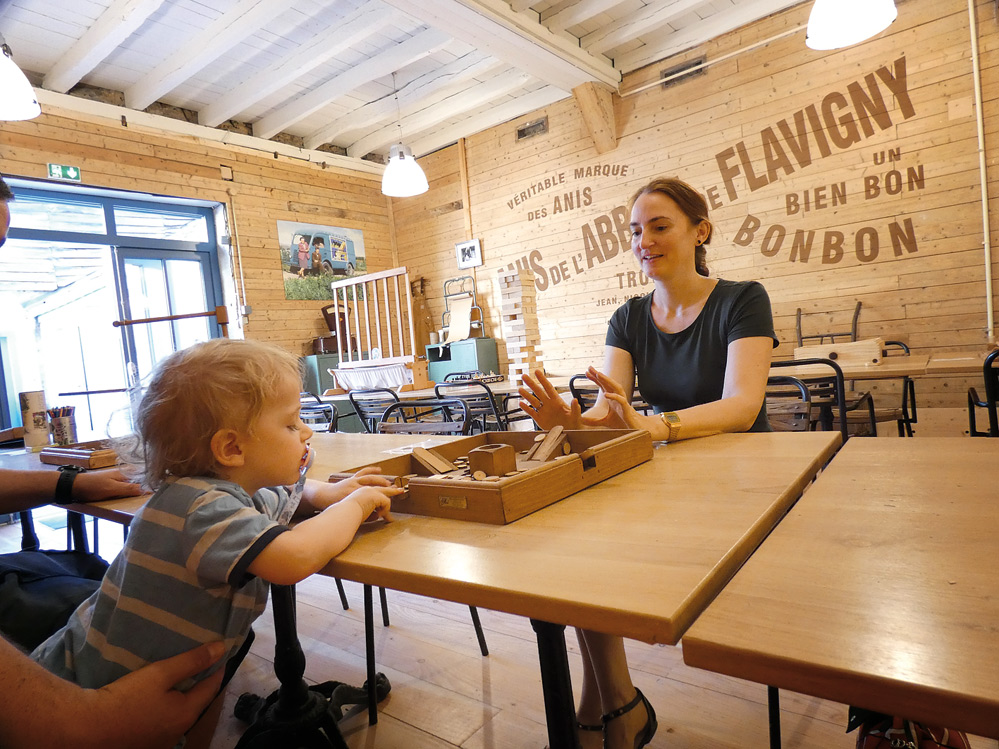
xmin=32 ymin=339 xmax=401 ymax=744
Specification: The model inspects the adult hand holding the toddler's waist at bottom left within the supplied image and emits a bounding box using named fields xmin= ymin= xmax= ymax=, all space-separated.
xmin=79 ymin=642 xmax=225 ymax=749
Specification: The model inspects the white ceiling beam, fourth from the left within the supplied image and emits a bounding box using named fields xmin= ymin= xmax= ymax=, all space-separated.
xmin=253 ymin=29 xmax=450 ymax=138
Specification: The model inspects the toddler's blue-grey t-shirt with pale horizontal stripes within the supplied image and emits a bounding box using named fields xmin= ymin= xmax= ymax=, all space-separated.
xmin=32 ymin=478 xmax=297 ymax=689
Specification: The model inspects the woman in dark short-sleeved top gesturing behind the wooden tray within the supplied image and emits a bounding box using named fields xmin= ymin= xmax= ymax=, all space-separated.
xmin=520 ymin=178 xmax=778 ymax=749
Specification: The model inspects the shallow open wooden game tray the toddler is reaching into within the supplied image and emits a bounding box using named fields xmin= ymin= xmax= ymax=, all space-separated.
xmin=329 ymin=429 xmax=652 ymax=525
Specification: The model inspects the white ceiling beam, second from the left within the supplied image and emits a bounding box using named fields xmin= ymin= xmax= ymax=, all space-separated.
xmin=125 ymin=0 xmax=287 ymax=110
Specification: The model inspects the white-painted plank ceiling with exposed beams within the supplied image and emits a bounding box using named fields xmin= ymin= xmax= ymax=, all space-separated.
xmin=0 ymin=0 xmax=802 ymax=165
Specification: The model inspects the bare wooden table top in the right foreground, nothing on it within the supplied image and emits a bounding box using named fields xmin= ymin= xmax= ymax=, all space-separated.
xmin=683 ymin=437 xmax=999 ymax=737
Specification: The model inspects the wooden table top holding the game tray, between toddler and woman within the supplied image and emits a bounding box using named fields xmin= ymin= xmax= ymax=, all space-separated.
xmin=324 ymin=432 xmax=839 ymax=643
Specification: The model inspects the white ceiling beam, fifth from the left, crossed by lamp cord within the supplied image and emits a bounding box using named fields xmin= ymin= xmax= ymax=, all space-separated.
xmin=305 ymin=52 xmax=503 ymax=148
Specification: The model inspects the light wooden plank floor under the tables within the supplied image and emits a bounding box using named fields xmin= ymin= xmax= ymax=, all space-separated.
xmin=0 ymin=494 xmax=999 ymax=749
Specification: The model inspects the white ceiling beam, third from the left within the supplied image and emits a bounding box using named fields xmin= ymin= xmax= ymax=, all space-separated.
xmin=198 ymin=0 xmax=399 ymax=128
